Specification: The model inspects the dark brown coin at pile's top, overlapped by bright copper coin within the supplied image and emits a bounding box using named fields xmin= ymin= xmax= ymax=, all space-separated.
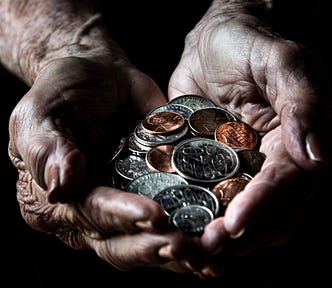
xmin=188 ymin=107 xmax=237 ymax=137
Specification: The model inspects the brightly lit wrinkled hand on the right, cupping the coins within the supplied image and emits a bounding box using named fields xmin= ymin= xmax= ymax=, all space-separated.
xmin=169 ymin=16 xmax=332 ymax=274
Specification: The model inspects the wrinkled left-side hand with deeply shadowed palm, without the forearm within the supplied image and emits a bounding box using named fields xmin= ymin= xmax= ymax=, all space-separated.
xmin=9 ymin=57 xmax=205 ymax=272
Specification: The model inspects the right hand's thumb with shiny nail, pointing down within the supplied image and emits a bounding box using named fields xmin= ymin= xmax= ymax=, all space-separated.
xmin=267 ymin=42 xmax=332 ymax=171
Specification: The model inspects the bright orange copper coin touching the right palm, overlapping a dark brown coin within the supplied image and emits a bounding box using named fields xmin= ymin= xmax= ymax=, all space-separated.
xmin=214 ymin=121 xmax=258 ymax=149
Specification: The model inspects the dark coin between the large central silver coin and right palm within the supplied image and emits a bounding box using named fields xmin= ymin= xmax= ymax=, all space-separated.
xmin=237 ymin=149 xmax=266 ymax=176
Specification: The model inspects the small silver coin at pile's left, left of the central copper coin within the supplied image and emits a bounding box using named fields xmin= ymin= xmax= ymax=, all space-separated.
xmin=115 ymin=154 xmax=152 ymax=180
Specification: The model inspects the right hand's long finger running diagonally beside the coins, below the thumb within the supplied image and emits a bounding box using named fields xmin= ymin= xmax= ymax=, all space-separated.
xmin=224 ymin=129 xmax=315 ymax=238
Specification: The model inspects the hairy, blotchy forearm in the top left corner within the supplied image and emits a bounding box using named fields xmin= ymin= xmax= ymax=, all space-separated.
xmin=0 ymin=0 xmax=120 ymax=84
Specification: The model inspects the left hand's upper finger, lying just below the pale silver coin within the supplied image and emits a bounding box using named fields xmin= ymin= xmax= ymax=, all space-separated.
xmin=79 ymin=186 xmax=169 ymax=237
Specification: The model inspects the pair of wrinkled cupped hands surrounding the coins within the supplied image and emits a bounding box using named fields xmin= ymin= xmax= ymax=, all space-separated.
xmin=9 ymin=16 xmax=332 ymax=276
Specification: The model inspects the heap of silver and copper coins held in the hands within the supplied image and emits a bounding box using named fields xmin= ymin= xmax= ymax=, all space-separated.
xmin=100 ymin=95 xmax=265 ymax=236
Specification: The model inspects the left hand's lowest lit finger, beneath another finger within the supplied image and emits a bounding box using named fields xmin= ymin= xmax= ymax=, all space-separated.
xmin=89 ymin=231 xmax=197 ymax=272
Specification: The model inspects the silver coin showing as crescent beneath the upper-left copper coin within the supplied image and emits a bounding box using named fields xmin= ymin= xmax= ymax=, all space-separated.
xmin=134 ymin=122 xmax=188 ymax=147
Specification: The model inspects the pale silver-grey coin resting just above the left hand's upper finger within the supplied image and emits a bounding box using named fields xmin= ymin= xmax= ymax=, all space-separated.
xmin=125 ymin=172 xmax=188 ymax=199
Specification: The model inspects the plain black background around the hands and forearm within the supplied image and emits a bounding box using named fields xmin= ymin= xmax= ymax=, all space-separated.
xmin=0 ymin=0 xmax=331 ymax=288
